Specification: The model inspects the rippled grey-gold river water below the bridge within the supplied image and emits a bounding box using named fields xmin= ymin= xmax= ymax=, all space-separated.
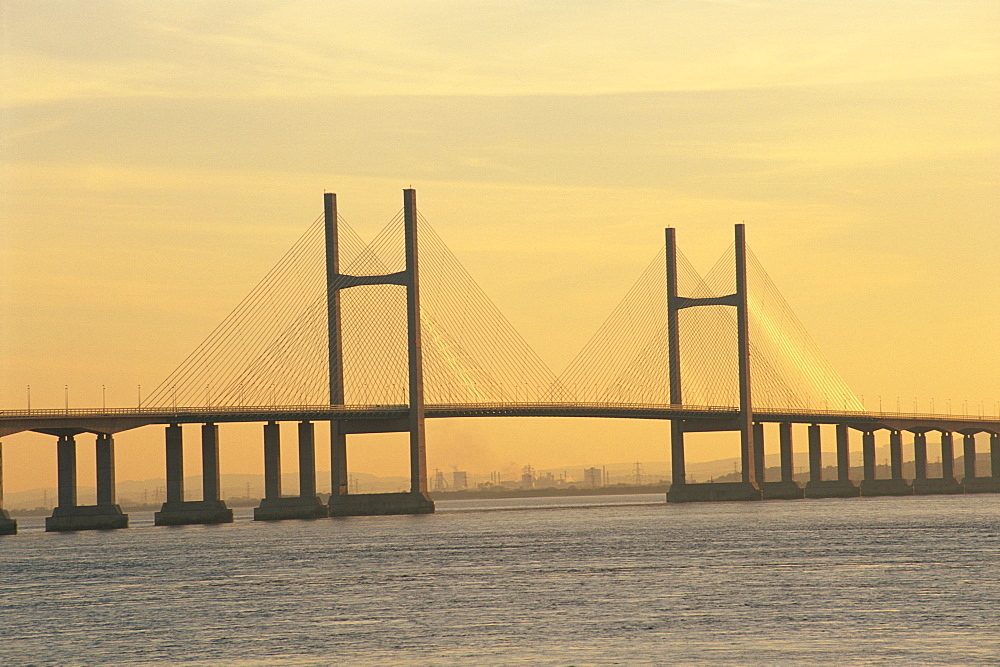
xmin=0 ymin=495 xmax=1000 ymax=665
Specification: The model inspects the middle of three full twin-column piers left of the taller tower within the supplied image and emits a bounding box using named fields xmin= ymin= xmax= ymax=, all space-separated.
xmin=153 ymin=424 xmax=233 ymax=526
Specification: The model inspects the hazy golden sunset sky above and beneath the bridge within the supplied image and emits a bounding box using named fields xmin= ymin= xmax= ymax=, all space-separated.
xmin=0 ymin=0 xmax=1000 ymax=490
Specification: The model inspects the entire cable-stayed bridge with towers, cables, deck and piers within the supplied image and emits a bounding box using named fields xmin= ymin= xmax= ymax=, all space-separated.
xmin=0 ymin=189 xmax=1000 ymax=534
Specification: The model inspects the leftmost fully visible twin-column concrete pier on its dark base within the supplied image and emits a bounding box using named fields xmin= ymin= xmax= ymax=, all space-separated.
xmin=45 ymin=433 xmax=128 ymax=532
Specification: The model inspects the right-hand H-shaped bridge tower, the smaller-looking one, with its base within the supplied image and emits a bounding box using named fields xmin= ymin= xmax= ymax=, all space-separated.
xmin=666 ymin=224 xmax=764 ymax=502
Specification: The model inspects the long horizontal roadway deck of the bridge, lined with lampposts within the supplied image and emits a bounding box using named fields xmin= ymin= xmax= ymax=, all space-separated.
xmin=0 ymin=402 xmax=1000 ymax=437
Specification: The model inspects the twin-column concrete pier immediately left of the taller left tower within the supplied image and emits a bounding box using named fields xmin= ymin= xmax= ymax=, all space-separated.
xmin=253 ymin=422 xmax=329 ymax=521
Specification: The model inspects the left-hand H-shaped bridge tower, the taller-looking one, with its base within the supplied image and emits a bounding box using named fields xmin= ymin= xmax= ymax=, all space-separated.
xmin=323 ymin=189 xmax=434 ymax=516
